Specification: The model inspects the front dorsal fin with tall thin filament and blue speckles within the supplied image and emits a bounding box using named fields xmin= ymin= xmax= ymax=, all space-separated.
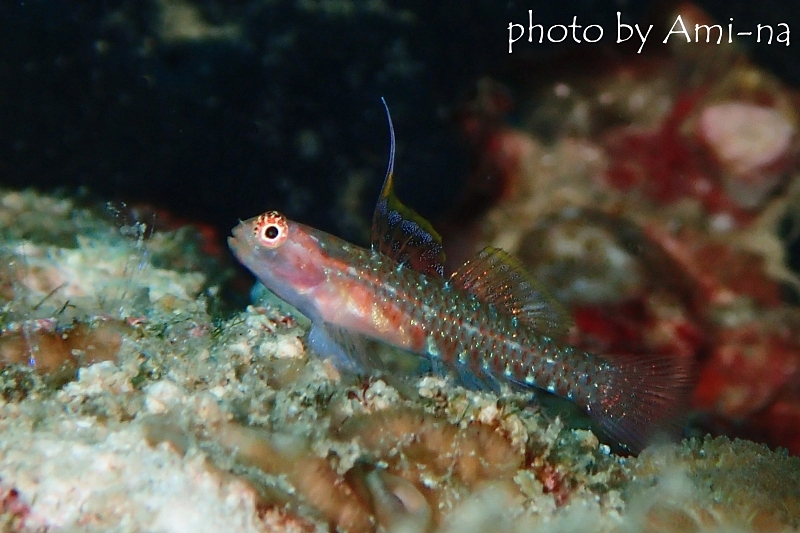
xmin=372 ymin=98 xmax=445 ymax=276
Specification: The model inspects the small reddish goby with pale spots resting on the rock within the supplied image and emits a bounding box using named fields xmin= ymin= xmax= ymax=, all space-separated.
xmin=228 ymin=102 xmax=691 ymax=453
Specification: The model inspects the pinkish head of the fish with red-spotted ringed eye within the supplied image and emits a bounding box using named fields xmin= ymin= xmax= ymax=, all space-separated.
xmin=228 ymin=211 xmax=332 ymax=317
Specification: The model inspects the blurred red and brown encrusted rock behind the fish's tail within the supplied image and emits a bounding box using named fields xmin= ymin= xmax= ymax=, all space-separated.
xmin=446 ymin=19 xmax=800 ymax=455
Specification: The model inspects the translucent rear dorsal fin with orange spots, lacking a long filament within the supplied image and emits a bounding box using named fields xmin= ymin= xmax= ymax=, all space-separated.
xmin=451 ymin=246 xmax=572 ymax=337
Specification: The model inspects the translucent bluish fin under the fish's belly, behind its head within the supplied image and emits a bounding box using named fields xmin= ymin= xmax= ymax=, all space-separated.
xmin=308 ymin=322 xmax=429 ymax=375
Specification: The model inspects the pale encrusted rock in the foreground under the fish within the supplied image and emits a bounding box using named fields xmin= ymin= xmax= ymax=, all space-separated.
xmin=0 ymin=188 xmax=800 ymax=533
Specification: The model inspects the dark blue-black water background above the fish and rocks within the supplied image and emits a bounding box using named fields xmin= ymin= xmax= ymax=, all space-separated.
xmin=0 ymin=0 xmax=800 ymax=248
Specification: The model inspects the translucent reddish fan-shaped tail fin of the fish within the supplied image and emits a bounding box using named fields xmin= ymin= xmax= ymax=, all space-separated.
xmin=586 ymin=355 xmax=693 ymax=453
